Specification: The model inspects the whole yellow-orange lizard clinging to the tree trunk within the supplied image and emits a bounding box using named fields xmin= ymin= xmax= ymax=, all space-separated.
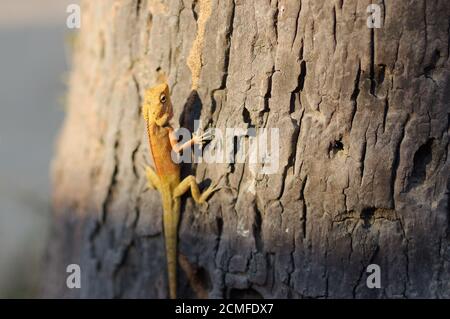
xmin=142 ymin=83 xmax=218 ymax=299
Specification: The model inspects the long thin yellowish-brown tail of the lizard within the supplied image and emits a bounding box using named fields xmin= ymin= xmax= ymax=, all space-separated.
xmin=163 ymin=198 xmax=180 ymax=299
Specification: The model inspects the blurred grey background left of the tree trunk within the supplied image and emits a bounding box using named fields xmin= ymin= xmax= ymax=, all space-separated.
xmin=0 ymin=0 xmax=78 ymax=298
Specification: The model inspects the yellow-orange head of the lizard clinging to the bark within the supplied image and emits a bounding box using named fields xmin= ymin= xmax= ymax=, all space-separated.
xmin=142 ymin=83 xmax=173 ymax=126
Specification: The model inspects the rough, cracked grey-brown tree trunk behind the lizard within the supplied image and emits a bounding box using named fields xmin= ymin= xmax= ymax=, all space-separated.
xmin=43 ymin=0 xmax=450 ymax=298
